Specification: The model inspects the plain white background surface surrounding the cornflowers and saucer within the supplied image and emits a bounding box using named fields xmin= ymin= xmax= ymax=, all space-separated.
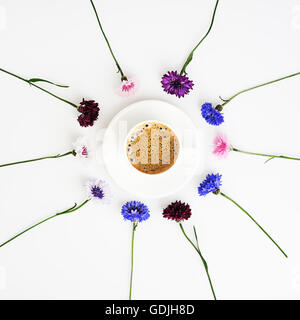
xmin=0 ymin=0 xmax=300 ymax=299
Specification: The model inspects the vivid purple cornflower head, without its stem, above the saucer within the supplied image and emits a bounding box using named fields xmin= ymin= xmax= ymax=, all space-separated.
xmin=161 ymin=71 xmax=194 ymax=98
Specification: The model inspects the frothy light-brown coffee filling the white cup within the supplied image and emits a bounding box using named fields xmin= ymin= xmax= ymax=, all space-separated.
xmin=126 ymin=122 xmax=179 ymax=174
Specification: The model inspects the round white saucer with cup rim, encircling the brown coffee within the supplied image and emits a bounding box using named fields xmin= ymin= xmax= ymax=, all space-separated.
xmin=102 ymin=100 xmax=203 ymax=198
